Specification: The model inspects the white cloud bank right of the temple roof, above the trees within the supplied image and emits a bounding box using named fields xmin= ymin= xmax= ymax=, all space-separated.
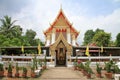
xmin=71 ymin=8 xmax=120 ymax=42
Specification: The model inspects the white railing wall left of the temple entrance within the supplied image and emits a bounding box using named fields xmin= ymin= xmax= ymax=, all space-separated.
xmin=0 ymin=56 xmax=52 ymax=66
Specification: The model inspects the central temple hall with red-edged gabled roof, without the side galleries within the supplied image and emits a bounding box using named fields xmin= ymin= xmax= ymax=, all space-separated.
xmin=44 ymin=9 xmax=79 ymax=66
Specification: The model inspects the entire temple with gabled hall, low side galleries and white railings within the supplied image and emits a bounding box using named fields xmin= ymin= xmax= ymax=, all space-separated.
xmin=0 ymin=8 xmax=120 ymax=67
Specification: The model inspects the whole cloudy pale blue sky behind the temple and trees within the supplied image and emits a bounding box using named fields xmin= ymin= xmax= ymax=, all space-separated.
xmin=0 ymin=0 xmax=120 ymax=45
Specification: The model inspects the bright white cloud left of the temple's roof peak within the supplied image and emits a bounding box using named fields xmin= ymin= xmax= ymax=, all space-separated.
xmin=13 ymin=0 xmax=60 ymax=40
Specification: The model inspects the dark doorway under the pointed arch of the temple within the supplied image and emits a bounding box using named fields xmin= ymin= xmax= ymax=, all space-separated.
xmin=56 ymin=42 xmax=66 ymax=66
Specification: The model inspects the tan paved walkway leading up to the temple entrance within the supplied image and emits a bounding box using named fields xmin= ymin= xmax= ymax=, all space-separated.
xmin=40 ymin=67 xmax=83 ymax=80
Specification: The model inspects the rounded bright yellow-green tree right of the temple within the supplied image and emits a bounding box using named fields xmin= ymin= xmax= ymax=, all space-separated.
xmin=93 ymin=31 xmax=111 ymax=46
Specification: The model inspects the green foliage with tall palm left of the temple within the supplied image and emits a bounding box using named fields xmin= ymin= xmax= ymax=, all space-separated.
xmin=0 ymin=15 xmax=44 ymax=53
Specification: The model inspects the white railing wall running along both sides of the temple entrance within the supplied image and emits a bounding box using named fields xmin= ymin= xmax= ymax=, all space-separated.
xmin=0 ymin=55 xmax=120 ymax=66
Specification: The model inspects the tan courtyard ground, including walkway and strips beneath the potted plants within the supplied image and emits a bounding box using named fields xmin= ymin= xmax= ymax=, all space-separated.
xmin=0 ymin=67 xmax=114 ymax=80
